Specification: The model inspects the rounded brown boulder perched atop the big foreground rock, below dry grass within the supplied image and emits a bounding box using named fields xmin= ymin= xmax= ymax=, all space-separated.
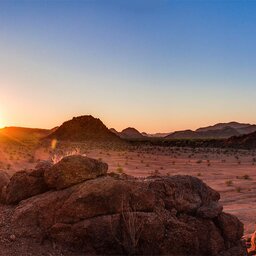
xmin=44 ymin=155 xmax=108 ymax=190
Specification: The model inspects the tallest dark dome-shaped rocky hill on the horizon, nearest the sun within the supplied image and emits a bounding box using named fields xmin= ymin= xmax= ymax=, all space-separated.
xmin=46 ymin=115 xmax=121 ymax=142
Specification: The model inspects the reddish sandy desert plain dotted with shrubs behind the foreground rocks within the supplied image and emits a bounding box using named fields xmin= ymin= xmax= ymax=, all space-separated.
xmin=0 ymin=142 xmax=256 ymax=234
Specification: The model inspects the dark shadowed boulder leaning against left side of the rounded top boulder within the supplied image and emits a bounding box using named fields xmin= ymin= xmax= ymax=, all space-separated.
xmin=3 ymin=163 xmax=51 ymax=204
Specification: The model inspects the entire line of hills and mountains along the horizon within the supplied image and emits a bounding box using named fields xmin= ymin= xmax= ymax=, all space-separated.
xmin=0 ymin=115 xmax=256 ymax=148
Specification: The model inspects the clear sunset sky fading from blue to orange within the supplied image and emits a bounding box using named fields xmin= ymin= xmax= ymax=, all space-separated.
xmin=0 ymin=0 xmax=256 ymax=133
